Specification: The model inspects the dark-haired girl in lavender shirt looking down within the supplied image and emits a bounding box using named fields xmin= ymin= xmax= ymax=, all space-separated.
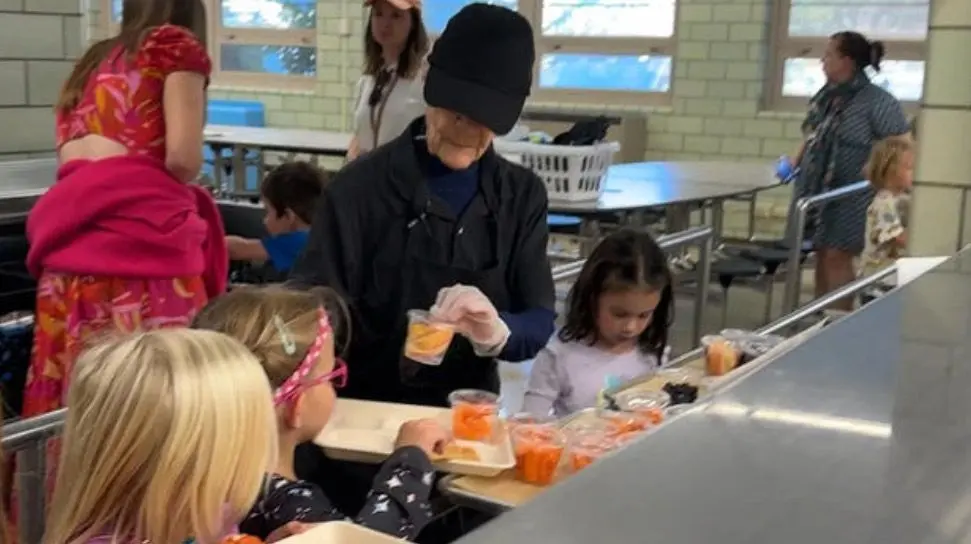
xmin=523 ymin=229 xmax=674 ymax=417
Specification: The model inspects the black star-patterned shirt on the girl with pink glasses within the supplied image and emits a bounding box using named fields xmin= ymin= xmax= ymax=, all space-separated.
xmin=240 ymin=447 xmax=435 ymax=540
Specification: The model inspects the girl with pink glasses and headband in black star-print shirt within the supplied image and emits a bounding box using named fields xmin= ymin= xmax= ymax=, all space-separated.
xmin=193 ymin=287 xmax=447 ymax=539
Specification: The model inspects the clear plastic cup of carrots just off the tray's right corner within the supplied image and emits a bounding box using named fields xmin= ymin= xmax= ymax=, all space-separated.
xmin=512 ymin=423 xmax=566 ymax=485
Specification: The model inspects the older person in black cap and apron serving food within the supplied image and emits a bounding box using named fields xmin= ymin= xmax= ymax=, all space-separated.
xmin=290 ymin=3 xmax=554 ymax=406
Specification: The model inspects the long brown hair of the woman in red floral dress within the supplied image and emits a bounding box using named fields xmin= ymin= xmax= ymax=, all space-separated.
xmin=56 ymin=0 xmax=206 ymax=111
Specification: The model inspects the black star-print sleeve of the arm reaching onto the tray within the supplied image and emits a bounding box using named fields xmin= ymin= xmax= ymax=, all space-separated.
xmin=355 ymin=446 xmax=435 ymax=540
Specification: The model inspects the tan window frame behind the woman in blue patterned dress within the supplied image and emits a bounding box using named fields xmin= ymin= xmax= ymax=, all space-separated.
xmin=763 ymin=0 xmax=927 ymax=113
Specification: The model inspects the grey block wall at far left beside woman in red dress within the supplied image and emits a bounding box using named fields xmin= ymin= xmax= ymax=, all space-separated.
xmin=0 ymin=0 xmax=84 ymax=160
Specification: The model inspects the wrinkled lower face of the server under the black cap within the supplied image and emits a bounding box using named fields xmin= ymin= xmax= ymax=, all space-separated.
xmin=425 ymin=107 xmax=495 ymax=170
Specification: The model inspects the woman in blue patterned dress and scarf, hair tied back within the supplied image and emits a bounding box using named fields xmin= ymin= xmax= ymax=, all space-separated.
xmin=790 ymin=32 xmax=909 ymax=310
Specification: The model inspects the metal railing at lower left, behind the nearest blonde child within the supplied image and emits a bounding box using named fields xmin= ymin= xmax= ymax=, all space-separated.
xmin=2 ymin=408 xmax=67 ymax=544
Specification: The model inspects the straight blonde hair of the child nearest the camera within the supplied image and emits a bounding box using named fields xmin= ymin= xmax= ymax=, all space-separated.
xmin=44 ymin=329 xmax=277 ymax=544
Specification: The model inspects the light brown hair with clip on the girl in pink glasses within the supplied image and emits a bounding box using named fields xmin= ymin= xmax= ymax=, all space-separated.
xmin=192 ymin=286 xmax=348 ymax=388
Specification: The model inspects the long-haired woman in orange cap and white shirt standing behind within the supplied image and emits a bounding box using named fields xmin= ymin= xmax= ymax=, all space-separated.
xmin=347 ymin=0 xmax=428 ymax=161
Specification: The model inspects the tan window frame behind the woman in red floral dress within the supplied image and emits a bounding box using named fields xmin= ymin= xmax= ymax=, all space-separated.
xmin=97 ymin=0 xmax=320 ymax=91
